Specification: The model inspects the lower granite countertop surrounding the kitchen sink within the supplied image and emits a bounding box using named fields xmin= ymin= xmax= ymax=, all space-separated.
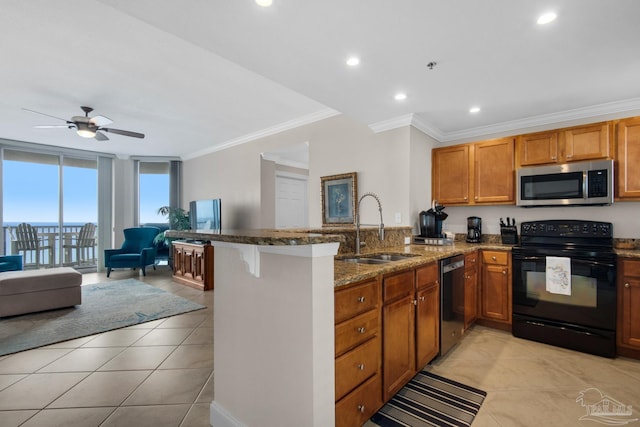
xmin=333 ymin=241 xmax=513 ymax=286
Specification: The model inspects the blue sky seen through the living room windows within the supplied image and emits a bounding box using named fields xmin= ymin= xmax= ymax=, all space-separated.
xmin=2 ymin=160 xmax=169 ymax=224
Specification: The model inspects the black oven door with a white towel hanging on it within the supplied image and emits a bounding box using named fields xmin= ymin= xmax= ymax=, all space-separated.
xmin=512 ymin=247 xmax=616 ymax=331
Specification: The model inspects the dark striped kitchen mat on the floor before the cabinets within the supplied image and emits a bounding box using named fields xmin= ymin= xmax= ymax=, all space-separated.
xmin=371 ymin=371 xmax=487 ymax=427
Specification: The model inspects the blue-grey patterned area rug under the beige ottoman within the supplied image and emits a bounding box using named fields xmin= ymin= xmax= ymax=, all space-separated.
xmin=0 ymin=279 xmax=206 ymax=356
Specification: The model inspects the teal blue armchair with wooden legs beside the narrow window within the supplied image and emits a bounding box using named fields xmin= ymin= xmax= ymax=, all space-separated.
xmin=104 ymin=227 xmax=160 ymax=277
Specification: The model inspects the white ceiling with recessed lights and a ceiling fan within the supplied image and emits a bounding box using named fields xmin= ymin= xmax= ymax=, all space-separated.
xmin=0 ymin=0 xmax=640 ymax=158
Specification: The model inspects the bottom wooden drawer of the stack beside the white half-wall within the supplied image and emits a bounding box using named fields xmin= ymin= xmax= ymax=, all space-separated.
xmin=336 ymin=374 xmax=382 ymax=427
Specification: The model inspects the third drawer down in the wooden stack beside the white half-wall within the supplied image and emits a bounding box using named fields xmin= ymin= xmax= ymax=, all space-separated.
xmin=336 ymin=336 xmax=382 ymax=400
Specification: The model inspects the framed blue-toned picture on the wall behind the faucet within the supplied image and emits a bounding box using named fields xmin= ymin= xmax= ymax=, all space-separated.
xmin=320 ymin=172 xmax=358 ymax=226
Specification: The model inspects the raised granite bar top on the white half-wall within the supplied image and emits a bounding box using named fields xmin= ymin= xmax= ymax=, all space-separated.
xmin=165 ymin=229 xmax=345 ymax=246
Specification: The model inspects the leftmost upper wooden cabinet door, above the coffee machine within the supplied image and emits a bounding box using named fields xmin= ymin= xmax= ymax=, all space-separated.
xmin=431 ymin=144 xmax=470 ymax=205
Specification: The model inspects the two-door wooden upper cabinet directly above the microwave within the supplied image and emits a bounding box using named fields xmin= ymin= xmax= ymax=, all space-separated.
xmin=517 ymin=122 xmax=613 ymax=166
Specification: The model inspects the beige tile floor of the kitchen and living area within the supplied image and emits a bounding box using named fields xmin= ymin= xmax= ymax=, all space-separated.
xmin=0 ymin=267 xmax=640 ymax=427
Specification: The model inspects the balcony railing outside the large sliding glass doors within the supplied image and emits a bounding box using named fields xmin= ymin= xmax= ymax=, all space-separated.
xmin=3 ymin=225 xmax=97 ymax=269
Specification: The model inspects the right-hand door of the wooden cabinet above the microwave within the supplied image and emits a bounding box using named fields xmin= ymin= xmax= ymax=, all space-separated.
xmin=560 ymin=123 xmax=610 ymax=162
